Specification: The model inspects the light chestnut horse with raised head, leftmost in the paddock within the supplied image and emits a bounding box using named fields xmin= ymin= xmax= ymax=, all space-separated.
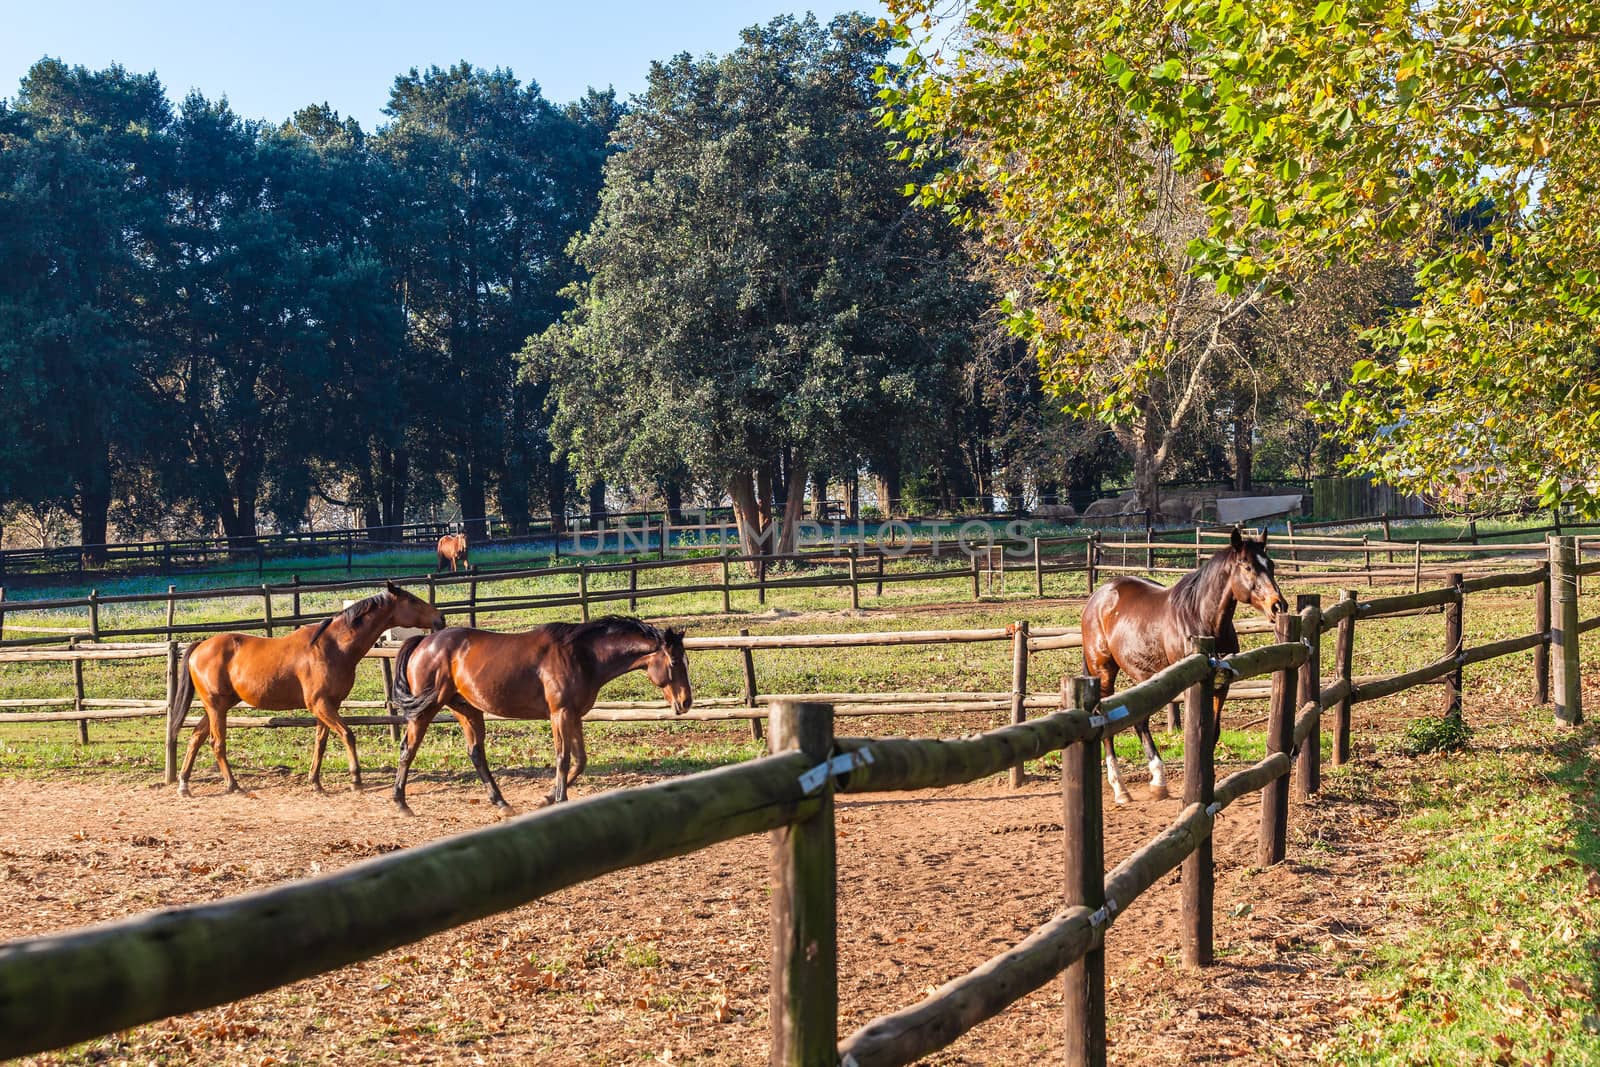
xmin=168 ymin=582 xmax=445 ymax=797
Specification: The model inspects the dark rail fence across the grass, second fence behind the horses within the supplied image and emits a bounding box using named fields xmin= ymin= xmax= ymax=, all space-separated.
xmin=0 ymin=526 xmax=1593 ymax=648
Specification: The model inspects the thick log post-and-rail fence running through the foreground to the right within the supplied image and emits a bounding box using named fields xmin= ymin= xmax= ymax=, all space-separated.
xmin=0 ymin=539 xmax=1600 ymax=1067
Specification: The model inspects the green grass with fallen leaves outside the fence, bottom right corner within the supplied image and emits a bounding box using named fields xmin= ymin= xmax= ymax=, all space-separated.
xmin=1328 ymin=709 xmax=1600 ymax=1065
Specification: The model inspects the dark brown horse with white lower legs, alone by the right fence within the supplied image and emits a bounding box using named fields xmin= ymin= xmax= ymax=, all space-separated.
xmin=1082 ymin=526 xmax=1288 ymax=805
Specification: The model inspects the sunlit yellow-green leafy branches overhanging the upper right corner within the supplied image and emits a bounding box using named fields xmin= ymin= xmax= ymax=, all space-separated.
xmin=891 ymin=0 xmax=1600 ymax=514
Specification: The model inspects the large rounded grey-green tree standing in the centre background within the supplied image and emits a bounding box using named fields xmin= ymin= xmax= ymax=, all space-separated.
xmin=525 ymin=16 xmax=978 ymax=553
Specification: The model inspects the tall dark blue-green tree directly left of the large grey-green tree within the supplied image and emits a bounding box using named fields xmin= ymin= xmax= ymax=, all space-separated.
xmin=378 ymin=62 xmax=616 ymax=536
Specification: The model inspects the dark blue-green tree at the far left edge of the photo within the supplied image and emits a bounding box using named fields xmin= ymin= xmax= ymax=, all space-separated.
xmin=0 ymin=59 xmax=171 ymax=557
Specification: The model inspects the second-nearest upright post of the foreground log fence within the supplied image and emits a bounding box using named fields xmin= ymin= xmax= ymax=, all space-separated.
xmin=1061 ymin=677 xmax=1109 ymax=1067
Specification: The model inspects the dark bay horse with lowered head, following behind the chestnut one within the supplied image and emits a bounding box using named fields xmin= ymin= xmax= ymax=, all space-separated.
xmin=394 ymin=614 xmax=694 ymax=814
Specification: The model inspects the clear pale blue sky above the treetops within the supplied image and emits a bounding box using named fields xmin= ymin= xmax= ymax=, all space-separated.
xmin=0 ymin=0 xmax=883 ymax=130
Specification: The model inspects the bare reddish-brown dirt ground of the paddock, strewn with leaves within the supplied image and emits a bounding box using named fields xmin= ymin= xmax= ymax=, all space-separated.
xmin=0 ymin=748 xmax=1395 ymax=1067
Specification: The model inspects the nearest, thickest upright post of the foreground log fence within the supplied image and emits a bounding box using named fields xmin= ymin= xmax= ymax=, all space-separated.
xmin=768 ymin=701 xmax=838 ymax=1067
